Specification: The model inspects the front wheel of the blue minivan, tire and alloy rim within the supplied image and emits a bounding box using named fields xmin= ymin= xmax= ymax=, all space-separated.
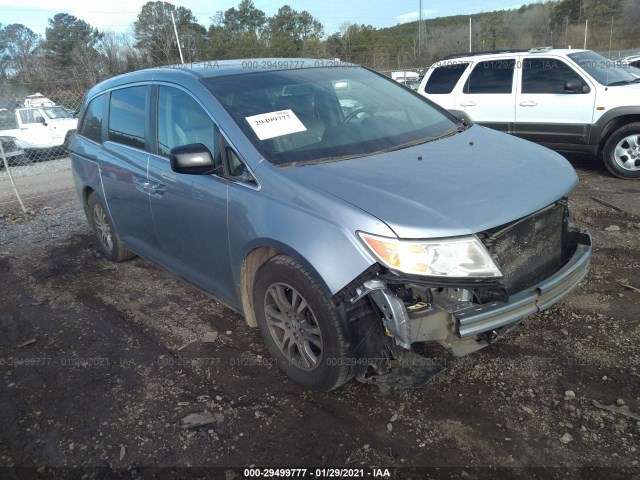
xmin=253 ymin=255 xmax=351 ymax=392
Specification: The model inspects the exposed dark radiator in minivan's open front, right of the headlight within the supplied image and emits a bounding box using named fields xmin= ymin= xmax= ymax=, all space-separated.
xmin=480 ymin=200 xmax=567 ymax=294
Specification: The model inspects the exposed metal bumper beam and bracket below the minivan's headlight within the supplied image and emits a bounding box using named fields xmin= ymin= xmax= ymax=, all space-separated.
xmin=351 ymin=232 xmax=591 ymax=356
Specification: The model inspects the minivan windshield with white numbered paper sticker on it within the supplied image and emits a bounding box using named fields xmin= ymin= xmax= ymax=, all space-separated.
xmin=204 ymin=66 xmax=457 ymax=165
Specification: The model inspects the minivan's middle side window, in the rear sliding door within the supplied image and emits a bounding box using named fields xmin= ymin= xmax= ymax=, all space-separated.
xmin=109 ymin=86 xmax=147 ymax=149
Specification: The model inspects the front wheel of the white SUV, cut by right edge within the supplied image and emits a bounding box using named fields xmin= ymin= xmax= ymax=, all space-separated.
xmin=602 ymin=122 xmax=640 ymax=178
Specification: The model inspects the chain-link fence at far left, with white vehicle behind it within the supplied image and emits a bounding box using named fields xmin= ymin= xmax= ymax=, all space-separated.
xmin=0 ymin=92 xmax=84 ymax=215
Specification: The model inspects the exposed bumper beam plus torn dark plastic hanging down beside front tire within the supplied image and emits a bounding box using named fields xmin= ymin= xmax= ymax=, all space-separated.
xmin=350 ymin=232 xmax=591 ymax=387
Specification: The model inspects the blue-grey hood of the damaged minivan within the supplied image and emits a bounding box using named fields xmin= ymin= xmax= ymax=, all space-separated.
xmin=281 ymin=126 xmax=578 ymax=238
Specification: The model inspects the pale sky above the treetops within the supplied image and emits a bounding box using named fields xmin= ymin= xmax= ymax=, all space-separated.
xmin=0 ymin=0 xmax=532 ymax=36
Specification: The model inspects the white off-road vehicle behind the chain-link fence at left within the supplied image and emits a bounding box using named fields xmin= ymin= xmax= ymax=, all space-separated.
xmin=0 ymin=106 xmax=78 ymax=157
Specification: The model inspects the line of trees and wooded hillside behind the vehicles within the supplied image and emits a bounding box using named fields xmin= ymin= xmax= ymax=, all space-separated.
xmin=0 ymin=0 xmax=640 ymax=96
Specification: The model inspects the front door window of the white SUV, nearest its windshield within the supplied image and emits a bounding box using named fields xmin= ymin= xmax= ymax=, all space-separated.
xmin=522 ymin=58 xmax=589 ymax=93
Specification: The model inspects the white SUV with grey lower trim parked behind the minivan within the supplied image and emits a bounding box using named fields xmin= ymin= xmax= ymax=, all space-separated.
xmin=418 ymin=47 xmax=640 ymax=178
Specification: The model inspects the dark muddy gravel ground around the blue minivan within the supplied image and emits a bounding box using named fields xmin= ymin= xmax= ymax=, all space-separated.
xmin=0 ymin=159 xmax=640 ymax=479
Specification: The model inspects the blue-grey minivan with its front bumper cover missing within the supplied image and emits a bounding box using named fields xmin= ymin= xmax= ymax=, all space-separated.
xmin=72 ymin=59 xmax=591 ymax=390
